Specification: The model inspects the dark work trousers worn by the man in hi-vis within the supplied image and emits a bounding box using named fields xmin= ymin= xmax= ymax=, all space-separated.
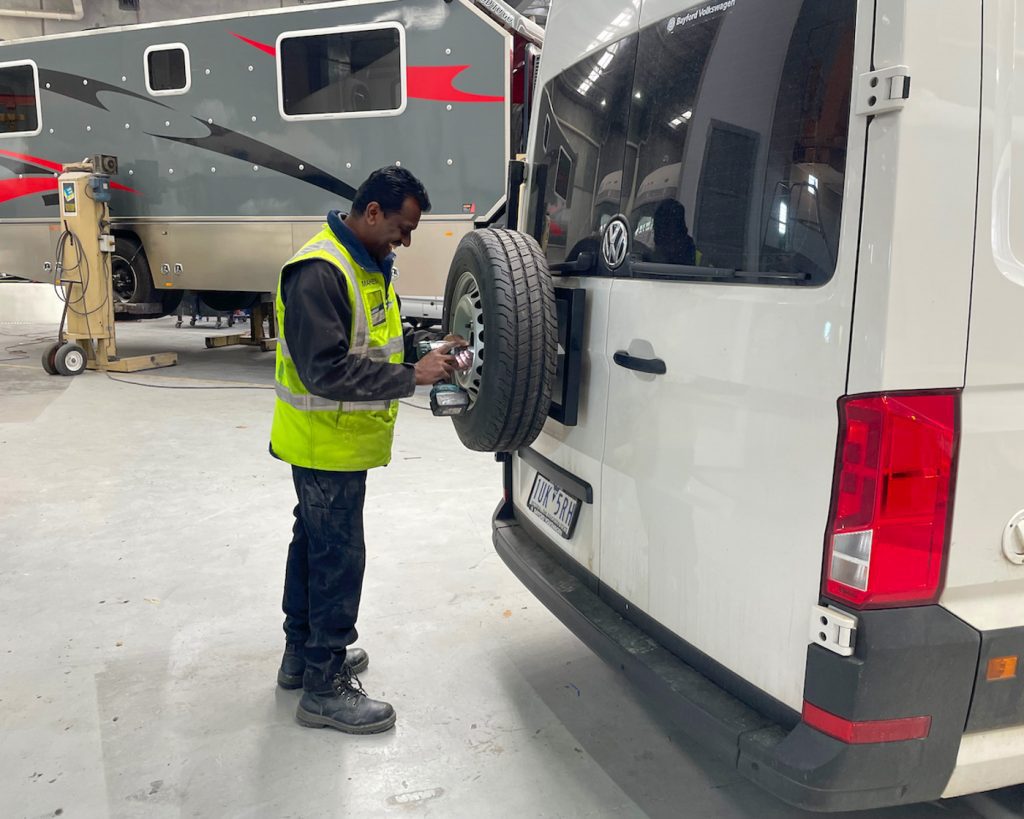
xmin=283 ymin=466 xmax=367 ymax=693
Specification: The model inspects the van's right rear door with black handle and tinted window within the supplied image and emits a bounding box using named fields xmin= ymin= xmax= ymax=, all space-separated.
xmin=601 ymin=0 xmax=872 ymax=710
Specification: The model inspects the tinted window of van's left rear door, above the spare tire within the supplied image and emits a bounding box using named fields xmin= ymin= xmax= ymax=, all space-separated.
xmin=526 ymin=35 xmax=637 ymax=269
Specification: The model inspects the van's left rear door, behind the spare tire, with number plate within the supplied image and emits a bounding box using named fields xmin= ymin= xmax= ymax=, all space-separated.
xmin=513 ymin=2 xmax=639 ymax=574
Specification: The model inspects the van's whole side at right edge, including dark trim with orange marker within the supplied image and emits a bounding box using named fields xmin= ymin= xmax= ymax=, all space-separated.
xmin=940 ymin=0 xmax=1024 ymax=782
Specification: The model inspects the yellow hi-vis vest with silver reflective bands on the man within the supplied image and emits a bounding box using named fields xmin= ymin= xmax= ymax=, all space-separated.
xmin=270 ymin=225 xmax=404 ymax=472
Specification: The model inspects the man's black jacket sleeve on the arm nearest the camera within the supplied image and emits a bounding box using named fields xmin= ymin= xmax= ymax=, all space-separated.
xmin=282 ymin=259 xmax=416 ymax=401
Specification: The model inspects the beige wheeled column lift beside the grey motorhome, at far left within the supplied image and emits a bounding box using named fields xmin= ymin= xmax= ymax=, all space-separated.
xmin=43 ymin=158 xmax=178 ymax=376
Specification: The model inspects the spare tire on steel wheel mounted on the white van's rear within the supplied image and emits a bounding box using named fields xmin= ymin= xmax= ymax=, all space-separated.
xmin=443 ymin=228 xmax=558 ymax=452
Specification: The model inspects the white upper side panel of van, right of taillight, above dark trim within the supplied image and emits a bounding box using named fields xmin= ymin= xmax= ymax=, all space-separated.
xmin=941 ymin=0 xmax=1024 ymax=638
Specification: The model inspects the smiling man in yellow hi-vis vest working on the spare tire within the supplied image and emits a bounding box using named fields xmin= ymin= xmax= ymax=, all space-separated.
xmin=270 ymin=167 xmax=465 ymax=734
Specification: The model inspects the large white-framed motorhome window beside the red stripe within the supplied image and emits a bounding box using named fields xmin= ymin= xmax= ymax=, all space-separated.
xmin=280 ymin=27 xmax=403 ymax=117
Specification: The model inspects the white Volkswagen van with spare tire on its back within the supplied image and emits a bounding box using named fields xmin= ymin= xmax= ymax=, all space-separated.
xmin=446 ymin=0 xmax=1024 ymax=811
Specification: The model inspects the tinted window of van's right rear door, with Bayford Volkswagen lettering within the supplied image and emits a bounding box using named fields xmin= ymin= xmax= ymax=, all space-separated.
xmin=627 ymin=0 xmax=856 ymax=285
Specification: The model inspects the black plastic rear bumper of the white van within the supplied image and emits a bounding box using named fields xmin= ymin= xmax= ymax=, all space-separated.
xmin=494 ymin=504 xmax=980 ymax=812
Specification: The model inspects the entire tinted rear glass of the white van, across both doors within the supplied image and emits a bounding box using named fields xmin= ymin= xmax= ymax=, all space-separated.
xmin=529 ymin=0 xmax=856 ymax=285
